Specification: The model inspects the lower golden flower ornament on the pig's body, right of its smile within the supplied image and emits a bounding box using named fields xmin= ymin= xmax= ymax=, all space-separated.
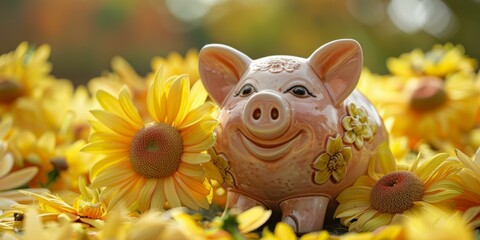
xmin=313 ymin=134 xmax=352 ymax=184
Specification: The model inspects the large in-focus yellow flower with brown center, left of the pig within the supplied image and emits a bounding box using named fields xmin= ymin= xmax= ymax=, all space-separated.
xmin=84 ymin=71 xmax=218 ymax=212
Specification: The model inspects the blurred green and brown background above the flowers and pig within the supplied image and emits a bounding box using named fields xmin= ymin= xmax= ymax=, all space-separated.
xmin=0 ymin=0 xmax=480 ymax=84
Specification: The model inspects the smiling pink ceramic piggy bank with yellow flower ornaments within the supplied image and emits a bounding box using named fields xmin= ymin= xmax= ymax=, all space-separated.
xmin=199 ymin=39 xmax=387 ymax=233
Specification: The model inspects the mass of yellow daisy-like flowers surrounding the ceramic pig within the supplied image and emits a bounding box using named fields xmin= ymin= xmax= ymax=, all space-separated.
xmin=0 ymin=42 xmax=480 ymax=239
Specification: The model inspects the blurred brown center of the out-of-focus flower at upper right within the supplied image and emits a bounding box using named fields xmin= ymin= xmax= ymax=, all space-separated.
xmin=410 ymin=77 xmax=447 ymax=111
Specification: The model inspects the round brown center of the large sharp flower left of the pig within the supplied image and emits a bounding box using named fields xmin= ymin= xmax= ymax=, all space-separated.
xmin=130 ymin=123 xmax=183 ymax=178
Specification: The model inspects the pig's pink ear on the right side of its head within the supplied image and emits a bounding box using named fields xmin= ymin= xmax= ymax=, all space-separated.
xmin=308 ymin=39 xmax=363 ymax=107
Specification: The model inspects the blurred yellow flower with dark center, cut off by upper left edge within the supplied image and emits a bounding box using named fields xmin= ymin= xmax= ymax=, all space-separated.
xmin=0 ymin=42 xmax=66 ymax=136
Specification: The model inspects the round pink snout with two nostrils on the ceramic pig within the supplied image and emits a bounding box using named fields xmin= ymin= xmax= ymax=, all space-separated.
xmin=242 ymin=91 xmax=290 ymax=139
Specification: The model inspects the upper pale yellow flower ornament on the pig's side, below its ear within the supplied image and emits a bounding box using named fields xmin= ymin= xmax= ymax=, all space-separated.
xmin=342 ymin=103 xmax=376 ymax=149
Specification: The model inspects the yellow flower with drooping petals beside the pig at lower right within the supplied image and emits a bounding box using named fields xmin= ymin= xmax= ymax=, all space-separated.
xmin=334 ymin=144 xmax=463 ymax=232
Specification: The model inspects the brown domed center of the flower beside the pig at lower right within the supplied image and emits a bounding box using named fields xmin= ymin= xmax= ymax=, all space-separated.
xmin=370 ymin=171 xmax=423 ymax=214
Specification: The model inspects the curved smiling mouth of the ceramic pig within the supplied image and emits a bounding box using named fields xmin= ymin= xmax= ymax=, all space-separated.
xmin=239 ymin=131 xmax=301 ymax=161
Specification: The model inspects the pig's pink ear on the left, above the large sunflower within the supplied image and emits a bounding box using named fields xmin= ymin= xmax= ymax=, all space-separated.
xmin=199 ymin=44 xmax=252 ymax=105
